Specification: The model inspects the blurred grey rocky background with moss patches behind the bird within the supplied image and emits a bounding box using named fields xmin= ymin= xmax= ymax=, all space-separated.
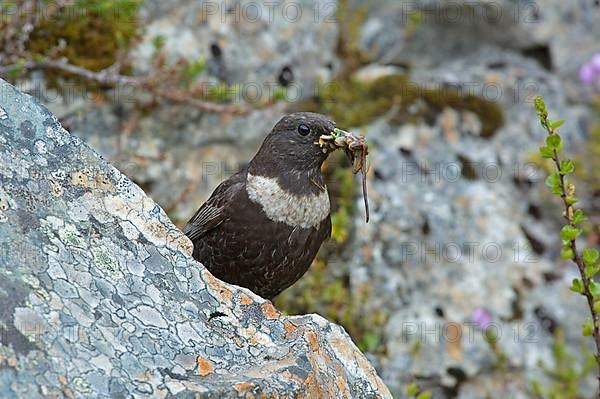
xmin=0 ymin=0 xmax=600 ymax=398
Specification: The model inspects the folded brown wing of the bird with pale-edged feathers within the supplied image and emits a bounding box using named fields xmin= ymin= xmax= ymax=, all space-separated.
xmin=183 ymin=172 xmax=245 ymax=241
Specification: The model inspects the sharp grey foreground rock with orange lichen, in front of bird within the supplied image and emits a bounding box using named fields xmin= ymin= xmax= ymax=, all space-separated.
xmin=0 ymin=81 xmax=390 ymax=399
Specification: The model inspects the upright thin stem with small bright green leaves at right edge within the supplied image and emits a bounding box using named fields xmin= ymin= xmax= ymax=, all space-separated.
xmin=535 ymin=96 xmax=600 ymax=394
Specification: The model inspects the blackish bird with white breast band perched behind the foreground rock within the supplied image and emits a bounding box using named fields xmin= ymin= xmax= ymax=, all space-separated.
xmin=183 ymin=112 xmax=356 ymax=299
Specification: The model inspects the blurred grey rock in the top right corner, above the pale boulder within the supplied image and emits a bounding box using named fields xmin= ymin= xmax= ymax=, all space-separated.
xmin=350 ymin=0 xmax=600 ymax=102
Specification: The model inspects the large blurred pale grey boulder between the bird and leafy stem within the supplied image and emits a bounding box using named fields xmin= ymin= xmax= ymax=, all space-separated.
xmin=341 ymin=48 xmax=594 ymax=399
